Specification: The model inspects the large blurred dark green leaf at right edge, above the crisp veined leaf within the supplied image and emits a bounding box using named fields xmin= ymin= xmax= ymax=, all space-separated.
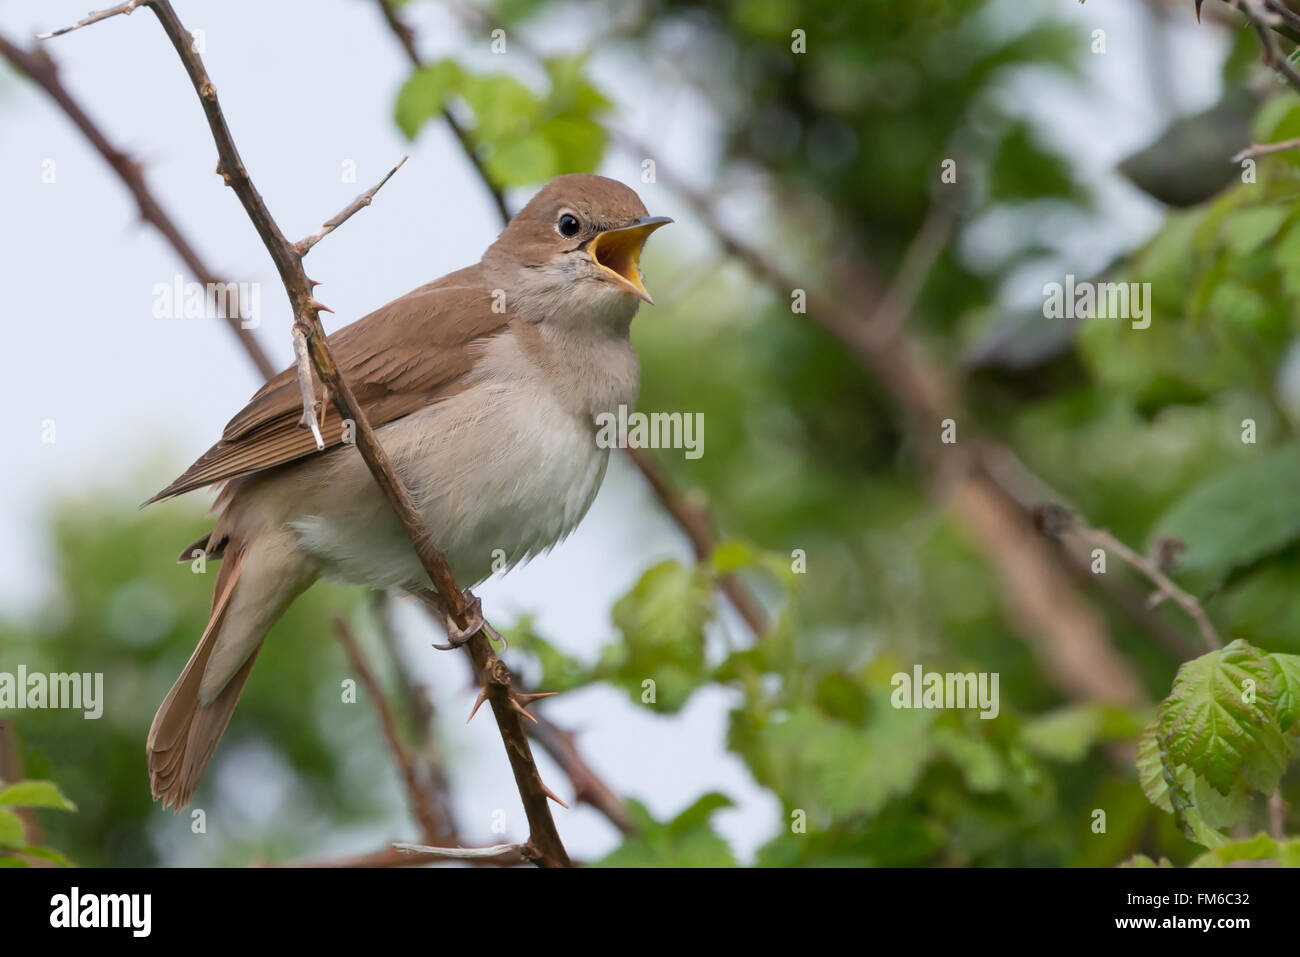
xmin=1156 ymin=446 xmax=1300 ymax=576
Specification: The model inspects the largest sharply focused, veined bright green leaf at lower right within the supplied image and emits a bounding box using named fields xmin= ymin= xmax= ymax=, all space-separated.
xmin=1158 ymin=641 xmax=1287 ymax=794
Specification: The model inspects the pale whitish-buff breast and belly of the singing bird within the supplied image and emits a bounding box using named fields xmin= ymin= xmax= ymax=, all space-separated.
xmin=275 ymin=327 xmax=624 ymax=588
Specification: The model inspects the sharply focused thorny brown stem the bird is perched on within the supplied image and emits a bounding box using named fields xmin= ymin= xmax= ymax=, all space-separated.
xmin=40 ymin=0 xmax=568 ymax=866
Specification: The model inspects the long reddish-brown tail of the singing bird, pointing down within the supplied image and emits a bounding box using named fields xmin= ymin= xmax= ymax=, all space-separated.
xmin=146 ymin=530 xmax=311 ymax=810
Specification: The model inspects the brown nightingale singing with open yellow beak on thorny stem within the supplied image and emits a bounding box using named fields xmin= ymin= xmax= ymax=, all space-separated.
xmin=146 ymin=174 xmax=671 ymax=810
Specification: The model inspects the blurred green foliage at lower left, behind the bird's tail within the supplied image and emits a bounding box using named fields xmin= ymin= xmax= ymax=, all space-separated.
xmin=0 ymin=488 xmax=402 ymax=866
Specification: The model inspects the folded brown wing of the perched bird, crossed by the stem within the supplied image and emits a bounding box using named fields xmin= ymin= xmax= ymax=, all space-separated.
xmin=144 ymin=265 xmax=508 ymax=505
